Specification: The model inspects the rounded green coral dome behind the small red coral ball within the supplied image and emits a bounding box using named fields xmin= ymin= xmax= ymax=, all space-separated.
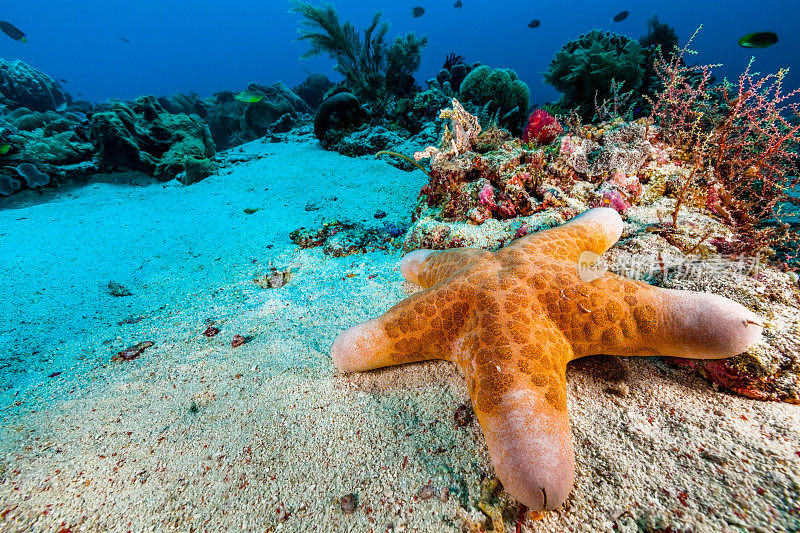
xmin=459 ymin=65 xmax=531 ymax=134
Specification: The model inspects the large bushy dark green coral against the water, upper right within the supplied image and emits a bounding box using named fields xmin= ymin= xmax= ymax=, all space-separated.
xmin=544 ymin=30 xmax=647 ymax=120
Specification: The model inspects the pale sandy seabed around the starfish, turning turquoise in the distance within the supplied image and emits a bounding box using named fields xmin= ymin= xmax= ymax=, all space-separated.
xmin=0 ymin=141 xmax=800 ymax=532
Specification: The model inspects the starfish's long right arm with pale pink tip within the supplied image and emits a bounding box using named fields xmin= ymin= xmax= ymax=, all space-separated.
xmin=564 ymin=273 xmax=763 ymax=359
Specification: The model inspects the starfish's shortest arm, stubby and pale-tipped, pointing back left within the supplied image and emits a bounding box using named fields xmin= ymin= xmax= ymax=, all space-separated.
xmin=400 ymin=248 xmax=492 ymax=288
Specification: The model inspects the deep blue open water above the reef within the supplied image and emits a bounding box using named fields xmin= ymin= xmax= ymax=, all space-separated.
xmin=0 ymin=0 xmax=800 ymax=104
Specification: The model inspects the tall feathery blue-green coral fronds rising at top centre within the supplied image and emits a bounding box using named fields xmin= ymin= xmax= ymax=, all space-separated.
xmin=291 ymin=0 xmax=428 ymax=114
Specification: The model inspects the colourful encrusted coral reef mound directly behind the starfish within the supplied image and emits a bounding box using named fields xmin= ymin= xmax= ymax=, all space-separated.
xmin=403 ymin=102 xmax=800 ymax=401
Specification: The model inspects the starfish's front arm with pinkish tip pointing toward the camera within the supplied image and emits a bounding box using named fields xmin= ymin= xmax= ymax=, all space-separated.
xmin=462 ymin=326 xmax=575 ymax=510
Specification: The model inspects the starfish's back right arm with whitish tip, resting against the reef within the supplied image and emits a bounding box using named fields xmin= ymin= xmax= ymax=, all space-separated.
xmin=506 ymin=207 xmax=622 ymax=262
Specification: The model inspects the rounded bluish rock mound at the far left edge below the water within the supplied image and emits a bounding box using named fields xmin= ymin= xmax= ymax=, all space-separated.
xmin=0 ymin=58 xmax=67 ymax=111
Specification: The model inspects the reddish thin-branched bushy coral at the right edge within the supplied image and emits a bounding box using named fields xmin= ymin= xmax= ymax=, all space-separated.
xmin=652 ymin=28 xmax=800 ymax=252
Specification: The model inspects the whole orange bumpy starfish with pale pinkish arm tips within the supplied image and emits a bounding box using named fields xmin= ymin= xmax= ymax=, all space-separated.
xmin=331 ymin=208 xmax=762 ymax=510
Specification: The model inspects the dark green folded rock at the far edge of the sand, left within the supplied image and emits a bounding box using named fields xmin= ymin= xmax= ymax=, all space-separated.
xmin=91 ymin=96 xmax=215 ymax=181
